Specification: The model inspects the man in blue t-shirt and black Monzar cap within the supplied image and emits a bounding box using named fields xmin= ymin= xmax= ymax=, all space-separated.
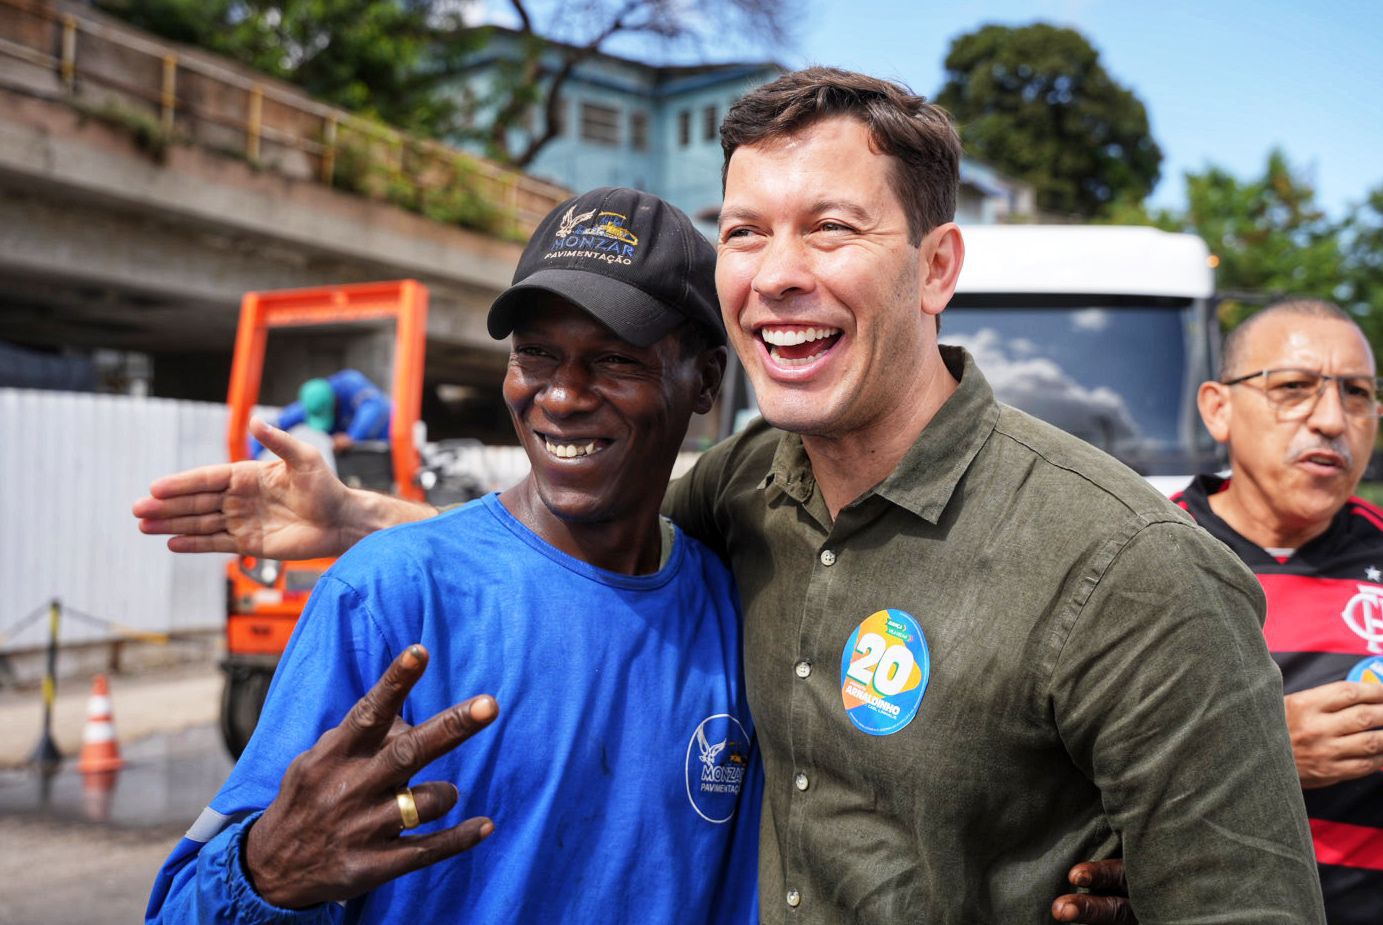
xmin=147 ymin=188 xmax=762 ymax=925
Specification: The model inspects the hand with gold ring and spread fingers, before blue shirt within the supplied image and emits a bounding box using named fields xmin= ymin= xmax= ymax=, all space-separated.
xmin=245 ymin=646 xmax=499 ymax=908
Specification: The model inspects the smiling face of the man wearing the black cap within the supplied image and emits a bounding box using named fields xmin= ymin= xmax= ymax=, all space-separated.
xmin=503 ymin=296 xmax=725 ymax=525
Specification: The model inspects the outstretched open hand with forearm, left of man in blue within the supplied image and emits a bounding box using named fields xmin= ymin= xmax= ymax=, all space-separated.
xmin=133 ymin=418 xmax=403 ymax=559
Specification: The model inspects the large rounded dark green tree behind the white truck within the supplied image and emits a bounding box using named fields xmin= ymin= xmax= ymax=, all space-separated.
xmin=938 ymin=22 xmax=1162 ymax=218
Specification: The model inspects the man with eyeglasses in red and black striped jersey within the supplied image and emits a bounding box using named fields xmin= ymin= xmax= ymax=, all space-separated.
xmin=1173 ymin=300 xmax=1383 ymax=925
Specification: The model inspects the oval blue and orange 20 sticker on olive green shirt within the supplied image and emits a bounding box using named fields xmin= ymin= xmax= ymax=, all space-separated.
xmin=841 ymin=608 xmax=932 ymax=736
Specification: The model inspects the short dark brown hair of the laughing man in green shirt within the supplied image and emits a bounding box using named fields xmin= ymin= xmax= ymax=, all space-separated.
xmin=721 ymin=68 xmax=961 ymax=246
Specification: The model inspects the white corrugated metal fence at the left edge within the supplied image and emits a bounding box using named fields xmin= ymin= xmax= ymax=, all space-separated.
xmin=0 ymin=389 xmax=225 ymax=651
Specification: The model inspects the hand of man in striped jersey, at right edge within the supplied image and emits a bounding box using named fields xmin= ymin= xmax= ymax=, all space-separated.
xmin=1286 ymin=680 xmax=1383 ymax=789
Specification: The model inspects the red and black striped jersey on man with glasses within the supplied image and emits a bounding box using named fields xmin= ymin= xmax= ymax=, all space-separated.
xmin=1171 ymin=476 xmax=1383 ymax=925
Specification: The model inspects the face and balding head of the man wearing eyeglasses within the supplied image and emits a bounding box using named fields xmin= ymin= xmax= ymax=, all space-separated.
xmin=1200 ymin=312 xmax=1377 ymax=548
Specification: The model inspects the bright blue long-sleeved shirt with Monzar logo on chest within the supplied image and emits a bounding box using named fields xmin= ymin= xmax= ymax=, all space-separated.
xmin=148 ymin=495 xmax=762 ymax=925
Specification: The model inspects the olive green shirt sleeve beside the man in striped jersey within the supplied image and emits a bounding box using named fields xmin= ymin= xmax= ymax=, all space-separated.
xmin=1051 ymin=520 xmax=1325 ymax=925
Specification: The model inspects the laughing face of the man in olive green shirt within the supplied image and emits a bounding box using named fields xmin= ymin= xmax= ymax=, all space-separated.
xmin=715 ymin=116 xmax=958 ymax=437
